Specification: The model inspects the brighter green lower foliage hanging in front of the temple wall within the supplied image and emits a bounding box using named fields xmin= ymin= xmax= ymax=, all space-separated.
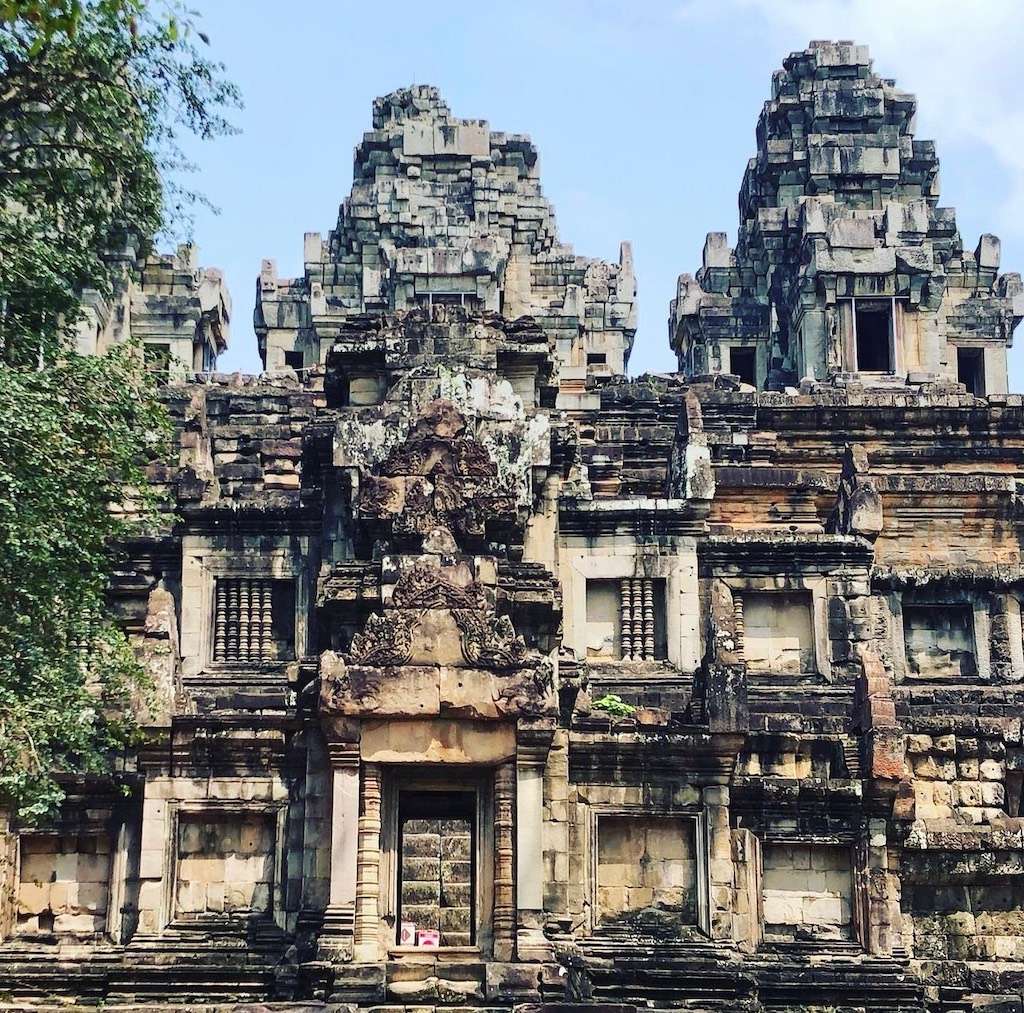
xmin=0 ymin=345 xmax=167 ymax=817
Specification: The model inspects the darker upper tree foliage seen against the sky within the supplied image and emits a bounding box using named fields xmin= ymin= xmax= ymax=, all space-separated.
xmin=0 ymin=0 xmax=237 ymax=367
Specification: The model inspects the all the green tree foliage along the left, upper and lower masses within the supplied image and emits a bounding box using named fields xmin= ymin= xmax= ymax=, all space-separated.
xmin=0 ymin=0 xmax=237 ymax=819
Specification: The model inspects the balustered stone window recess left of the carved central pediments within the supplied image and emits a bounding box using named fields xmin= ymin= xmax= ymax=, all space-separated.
xmin=213 ymin=577 xmax=295 ymax=664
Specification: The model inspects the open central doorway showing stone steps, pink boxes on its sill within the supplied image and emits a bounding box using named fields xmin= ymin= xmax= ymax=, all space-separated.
xmin=396 ymin=790 xmax=476 ymax=946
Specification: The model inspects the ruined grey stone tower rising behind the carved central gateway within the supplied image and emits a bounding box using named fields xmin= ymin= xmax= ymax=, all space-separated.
xmin=256 ymin=85 xmax=636 ymax=392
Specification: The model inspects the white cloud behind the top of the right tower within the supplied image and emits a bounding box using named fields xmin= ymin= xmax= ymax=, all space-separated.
xmin=676 ymin=0 xmax=1024 ymax=235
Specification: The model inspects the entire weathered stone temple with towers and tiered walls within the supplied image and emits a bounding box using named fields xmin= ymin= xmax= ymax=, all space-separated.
xmin=0 ymin=42 xmax=1024 ymax=1013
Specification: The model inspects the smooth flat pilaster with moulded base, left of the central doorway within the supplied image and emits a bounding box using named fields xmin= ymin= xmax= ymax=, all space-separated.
xmin=319 ymin=742 xmax=364 ymax=960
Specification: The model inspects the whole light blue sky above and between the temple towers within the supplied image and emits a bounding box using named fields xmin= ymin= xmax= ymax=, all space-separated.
xmin=180 ymin=0 xmax=1024 ymax=390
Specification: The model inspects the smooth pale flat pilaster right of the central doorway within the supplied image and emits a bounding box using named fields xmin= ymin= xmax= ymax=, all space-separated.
xmin=515 ymin=728 xmax=552 ymax=960
